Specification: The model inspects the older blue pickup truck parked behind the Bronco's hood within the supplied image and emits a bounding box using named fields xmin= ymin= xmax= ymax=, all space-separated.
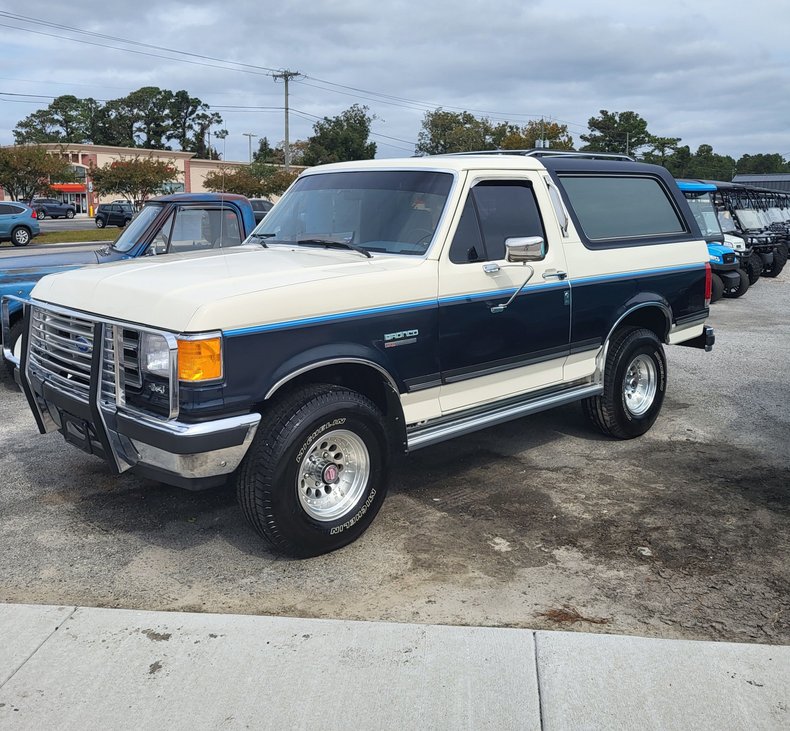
xmin=0 ymin=193 xmax=255 ymax=379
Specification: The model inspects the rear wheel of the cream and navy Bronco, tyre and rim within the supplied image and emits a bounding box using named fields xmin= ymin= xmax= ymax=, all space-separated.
xmin=583 ymin=328 xmax=667 ymax=439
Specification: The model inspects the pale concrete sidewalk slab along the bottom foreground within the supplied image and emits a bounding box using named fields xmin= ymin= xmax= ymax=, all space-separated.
xmin=0 ymin=604 xmax=790 ymax=730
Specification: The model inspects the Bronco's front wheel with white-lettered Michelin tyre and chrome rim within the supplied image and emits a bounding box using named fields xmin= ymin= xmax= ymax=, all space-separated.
xmin=236 ymin=384 xmax=390 ymax=558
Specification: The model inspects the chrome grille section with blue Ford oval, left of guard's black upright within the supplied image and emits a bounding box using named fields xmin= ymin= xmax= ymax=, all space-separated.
xmin=28 ymin=307 xmax=93 ymax=402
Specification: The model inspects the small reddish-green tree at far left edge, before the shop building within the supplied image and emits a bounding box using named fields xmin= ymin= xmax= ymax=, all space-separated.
xmin=0 ymin=145 xmax=74 ymax=201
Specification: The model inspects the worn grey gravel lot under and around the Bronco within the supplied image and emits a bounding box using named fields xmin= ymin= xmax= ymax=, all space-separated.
xmin=0 ymin=274 xmax=790 ymax=644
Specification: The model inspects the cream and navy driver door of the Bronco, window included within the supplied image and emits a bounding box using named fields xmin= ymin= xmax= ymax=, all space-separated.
xmin=439 ymin=172 xmax=570 ymax=414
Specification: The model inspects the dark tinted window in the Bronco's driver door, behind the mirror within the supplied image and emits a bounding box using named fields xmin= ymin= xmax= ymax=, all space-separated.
xmin=450 ymin=180 xmax=546 ymax=264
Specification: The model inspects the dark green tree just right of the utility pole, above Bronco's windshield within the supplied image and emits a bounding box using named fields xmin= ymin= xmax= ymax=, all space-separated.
xmin=302 ymin=104 xmax=376 ymax=165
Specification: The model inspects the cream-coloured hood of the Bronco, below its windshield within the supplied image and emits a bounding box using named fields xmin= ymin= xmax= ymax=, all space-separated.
xmin=32 ymin=245 xmax=436 ymax=332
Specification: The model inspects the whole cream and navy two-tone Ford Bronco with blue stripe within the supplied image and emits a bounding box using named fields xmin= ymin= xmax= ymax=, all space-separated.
xmin=3 ymin=151 xmax=714 ymax=556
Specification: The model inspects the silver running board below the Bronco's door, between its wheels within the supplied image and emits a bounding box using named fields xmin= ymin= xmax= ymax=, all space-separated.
xmin=407 ymin=383 xmax=603 ymax=452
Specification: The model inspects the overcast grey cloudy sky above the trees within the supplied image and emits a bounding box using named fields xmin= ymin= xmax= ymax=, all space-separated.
xmin=0 ymin=0 xmax=790 ymax=160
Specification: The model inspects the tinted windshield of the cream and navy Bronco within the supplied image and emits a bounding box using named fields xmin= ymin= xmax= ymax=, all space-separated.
xmin=254 ymin=170 xmax=453 ymax=256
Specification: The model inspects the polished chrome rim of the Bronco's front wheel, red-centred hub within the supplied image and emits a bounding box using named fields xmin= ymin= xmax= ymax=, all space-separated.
xmin=296 ymin=429 xmax=370 ymax=522
